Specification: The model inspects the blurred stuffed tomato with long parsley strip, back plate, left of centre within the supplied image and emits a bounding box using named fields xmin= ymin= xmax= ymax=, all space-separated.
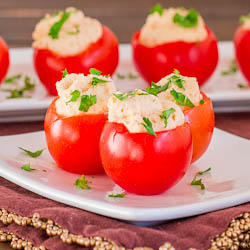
xmin=33 ymin=8 xmax=119 ymax=95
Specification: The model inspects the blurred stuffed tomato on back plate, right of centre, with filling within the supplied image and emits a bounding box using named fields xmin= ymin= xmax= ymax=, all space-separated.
xmin=132 ymin=7 xmax=218 ymax=86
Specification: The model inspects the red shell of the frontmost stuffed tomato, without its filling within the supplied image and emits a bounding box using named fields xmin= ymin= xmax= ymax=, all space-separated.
xmin=100 ymin=122 xmax=192 ymax=195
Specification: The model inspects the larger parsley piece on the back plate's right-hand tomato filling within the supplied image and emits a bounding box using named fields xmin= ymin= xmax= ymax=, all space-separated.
xmin=173 ymin=9 xmax=199 ymax=28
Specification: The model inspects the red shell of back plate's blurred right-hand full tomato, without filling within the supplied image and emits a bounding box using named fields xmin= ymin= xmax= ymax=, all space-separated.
xmin=132 ymin=27 xmax=218 ymax=86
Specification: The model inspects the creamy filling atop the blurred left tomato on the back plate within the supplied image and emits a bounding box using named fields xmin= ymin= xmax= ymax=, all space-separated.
xmin=32 ymin=8 xmax=103 ymax=56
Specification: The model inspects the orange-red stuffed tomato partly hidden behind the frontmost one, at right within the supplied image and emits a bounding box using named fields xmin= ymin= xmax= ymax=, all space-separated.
xmin=146 ymin=70 xmax=215 ymax=162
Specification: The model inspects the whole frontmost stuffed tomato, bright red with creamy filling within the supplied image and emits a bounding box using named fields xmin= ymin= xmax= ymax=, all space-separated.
xmin=100 ymin=90 xmax=192 ymax=195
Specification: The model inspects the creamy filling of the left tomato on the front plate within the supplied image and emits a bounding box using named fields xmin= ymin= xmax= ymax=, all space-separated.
xmin=55 ymin=74 xmax=116 ymax=117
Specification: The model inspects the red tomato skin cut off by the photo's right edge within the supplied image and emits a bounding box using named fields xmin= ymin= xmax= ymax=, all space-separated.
xmin=234 ymin=26 xmax=250 ymax=85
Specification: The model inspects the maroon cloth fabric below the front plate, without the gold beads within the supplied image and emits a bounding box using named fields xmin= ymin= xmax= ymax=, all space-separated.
xmin=0 ymin=178 xmax=250 ymax=250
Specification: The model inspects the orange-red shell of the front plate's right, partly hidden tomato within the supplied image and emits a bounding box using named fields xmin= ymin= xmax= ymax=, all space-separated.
xmin=184 ymin=93 xmax=214 ymax=162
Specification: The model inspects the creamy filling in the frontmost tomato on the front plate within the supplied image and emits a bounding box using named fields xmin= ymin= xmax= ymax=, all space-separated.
xmin=108 ymin=90 xmax=185 ymax=133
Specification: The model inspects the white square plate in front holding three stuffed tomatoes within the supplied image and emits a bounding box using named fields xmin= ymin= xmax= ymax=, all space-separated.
xmin=0 ymin=129 xmax=250 ymax=223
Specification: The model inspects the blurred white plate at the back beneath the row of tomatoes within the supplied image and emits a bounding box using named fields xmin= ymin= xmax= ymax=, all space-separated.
xmin=0 ymin=42 xmax=250 ymax=122
